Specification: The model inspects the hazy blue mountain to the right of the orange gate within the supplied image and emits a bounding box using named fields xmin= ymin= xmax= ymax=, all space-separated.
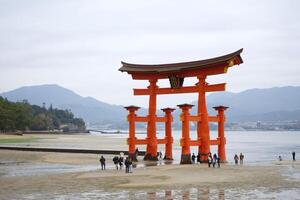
xmin=194 ymin=86 xmax=300 ymax=122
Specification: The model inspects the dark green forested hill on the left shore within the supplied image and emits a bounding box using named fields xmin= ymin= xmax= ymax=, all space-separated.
xmin=0 ymin=97 xmax=85 ymax=132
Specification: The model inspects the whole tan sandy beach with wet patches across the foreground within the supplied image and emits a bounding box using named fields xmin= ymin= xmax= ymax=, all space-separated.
xmin=0 ymin=135 xmax=300 ymax=199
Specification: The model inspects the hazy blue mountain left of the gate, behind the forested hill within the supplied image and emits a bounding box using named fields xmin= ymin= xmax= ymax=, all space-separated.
xmin=0 ymin=85 xmax=133 ymax=126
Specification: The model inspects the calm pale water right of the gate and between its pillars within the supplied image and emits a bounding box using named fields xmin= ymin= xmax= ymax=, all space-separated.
xmin=146 ymin=131 xmax=300 ymax=164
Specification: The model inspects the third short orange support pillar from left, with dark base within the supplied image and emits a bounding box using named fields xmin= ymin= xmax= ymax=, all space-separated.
xmin=178 ymin=104 xmax=194 ymax=164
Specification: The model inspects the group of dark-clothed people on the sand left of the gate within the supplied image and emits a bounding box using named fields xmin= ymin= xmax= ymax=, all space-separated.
xmin=99 ymin=154 xmax=132 ymax=173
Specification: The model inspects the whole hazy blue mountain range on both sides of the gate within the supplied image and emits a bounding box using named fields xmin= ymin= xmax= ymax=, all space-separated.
xmin=0 ymin=85 xmax=300 ymax=128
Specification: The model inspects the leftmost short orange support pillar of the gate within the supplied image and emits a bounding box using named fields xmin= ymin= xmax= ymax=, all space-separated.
xmin=125 ymin=106 xmax=140 ymax=161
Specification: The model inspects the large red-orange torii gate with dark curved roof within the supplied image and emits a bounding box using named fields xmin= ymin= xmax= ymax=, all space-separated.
xmin=119 ymin=49 xmax=243 ymax=163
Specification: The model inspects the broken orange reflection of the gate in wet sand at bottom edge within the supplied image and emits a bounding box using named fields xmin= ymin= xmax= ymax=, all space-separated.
xmin=147 ymin=187 xmax=225 ymax=200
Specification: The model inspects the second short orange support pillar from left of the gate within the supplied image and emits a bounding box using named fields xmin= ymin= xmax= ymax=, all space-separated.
xmin=161 ymin=108 xmax=175 ymax=160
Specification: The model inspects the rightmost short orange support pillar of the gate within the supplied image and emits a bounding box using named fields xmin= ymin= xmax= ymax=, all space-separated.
xmin=214 ymin=106 xmax=228 ymax=162
